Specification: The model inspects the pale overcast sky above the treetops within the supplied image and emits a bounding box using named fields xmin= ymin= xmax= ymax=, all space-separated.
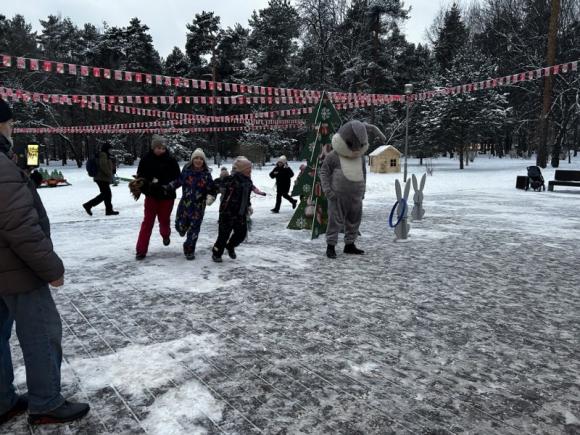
xmin=0 ymin=0 xmax=448 ymax=57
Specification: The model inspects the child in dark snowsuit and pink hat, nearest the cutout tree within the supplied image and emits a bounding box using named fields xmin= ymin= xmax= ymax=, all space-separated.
xmin=212 ymin=156 xmax=253 ymax=263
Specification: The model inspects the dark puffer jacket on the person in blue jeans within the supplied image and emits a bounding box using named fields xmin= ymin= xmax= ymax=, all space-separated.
xmin=0 ymin=146 xmax=64 ymax=296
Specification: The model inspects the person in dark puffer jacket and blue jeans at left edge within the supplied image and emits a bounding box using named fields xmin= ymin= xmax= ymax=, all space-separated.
xmin=0 ymin=99 xmax=89 ymax=424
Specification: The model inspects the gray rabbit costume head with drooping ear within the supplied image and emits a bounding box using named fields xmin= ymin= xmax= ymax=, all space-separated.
xmin=332 ymin=121 xmax=387 ymax=159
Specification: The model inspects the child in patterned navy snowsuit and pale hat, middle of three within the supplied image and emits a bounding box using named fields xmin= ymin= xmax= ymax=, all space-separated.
xmin=172 ymin=148 xmax=217 ymax=260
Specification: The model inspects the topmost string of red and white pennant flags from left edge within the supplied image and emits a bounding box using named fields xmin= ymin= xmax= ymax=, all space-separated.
xmin=0 ymin=54 xmax=402 ymax=104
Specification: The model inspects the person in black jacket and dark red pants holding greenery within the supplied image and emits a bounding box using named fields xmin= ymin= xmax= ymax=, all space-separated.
xmin=136 ymin=135 xmax=180 ymax=260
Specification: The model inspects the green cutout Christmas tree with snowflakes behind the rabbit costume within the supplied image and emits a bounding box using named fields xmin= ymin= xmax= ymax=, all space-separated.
xmin=288 ymin=93 xmax=341 ymax=239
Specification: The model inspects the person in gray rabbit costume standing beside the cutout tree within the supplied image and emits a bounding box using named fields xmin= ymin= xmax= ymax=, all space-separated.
xmin=320 ymin=121 xmax=386 ymax=258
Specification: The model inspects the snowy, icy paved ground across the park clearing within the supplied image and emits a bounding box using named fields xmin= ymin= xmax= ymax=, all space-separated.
xmin=2 ymin=156 xmax=580 ymax=435
